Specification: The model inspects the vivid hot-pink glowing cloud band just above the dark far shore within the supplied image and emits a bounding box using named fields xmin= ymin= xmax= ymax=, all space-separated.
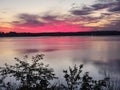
xmin=14 ymin=22 xmax=93 ymax=33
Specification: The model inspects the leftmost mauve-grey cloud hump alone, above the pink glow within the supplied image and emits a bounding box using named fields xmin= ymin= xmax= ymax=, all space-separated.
xmin=13 ymin=14 xmax=45 ymax=26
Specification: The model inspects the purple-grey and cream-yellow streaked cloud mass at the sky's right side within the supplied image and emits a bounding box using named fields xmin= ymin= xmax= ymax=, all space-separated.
xmin=70 ymin=0 xmax=120 ymax=30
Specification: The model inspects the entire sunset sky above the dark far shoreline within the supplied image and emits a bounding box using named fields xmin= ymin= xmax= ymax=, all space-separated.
xmin=0 ymin=0 xmax=120 ymax=33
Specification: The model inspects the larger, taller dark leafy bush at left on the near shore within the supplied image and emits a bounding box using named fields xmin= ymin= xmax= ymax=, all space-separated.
xmin=0 ymin=54 xmax=55 ymax=90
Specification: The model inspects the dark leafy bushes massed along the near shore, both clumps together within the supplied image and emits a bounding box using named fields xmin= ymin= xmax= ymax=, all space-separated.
xmin=0 ymin=54 xmax=113 ymax=90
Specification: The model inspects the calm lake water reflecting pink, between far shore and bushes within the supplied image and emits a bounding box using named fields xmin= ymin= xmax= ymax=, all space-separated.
xmin=0 ymin=37 xmax=120 ymax=81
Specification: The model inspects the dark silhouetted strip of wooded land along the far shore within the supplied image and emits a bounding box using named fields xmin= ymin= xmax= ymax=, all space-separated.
xmin=0 ymin=31 xmax=120 ymax=37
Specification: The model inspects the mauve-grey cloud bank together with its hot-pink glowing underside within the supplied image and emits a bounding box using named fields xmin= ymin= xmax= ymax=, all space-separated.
xmin=12 ymin=14 xmax=92 ymax=33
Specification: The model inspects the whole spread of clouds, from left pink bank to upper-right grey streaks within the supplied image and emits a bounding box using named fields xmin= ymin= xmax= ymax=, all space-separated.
xmin=0 ymin=0 xmax=120 ymax=32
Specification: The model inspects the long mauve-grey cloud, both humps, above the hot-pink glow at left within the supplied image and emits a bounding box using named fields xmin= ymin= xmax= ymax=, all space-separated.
xmin=12 ymin=13 xmax=64 ymax=27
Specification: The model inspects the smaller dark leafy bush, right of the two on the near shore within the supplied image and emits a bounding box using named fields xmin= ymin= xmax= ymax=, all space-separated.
xmin=63 ymin=65 xmax=109 ymax=90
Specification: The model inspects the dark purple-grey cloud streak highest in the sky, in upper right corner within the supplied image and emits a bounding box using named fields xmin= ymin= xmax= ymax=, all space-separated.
xmin=70 ymin=0 xmax=120 ymax=15
